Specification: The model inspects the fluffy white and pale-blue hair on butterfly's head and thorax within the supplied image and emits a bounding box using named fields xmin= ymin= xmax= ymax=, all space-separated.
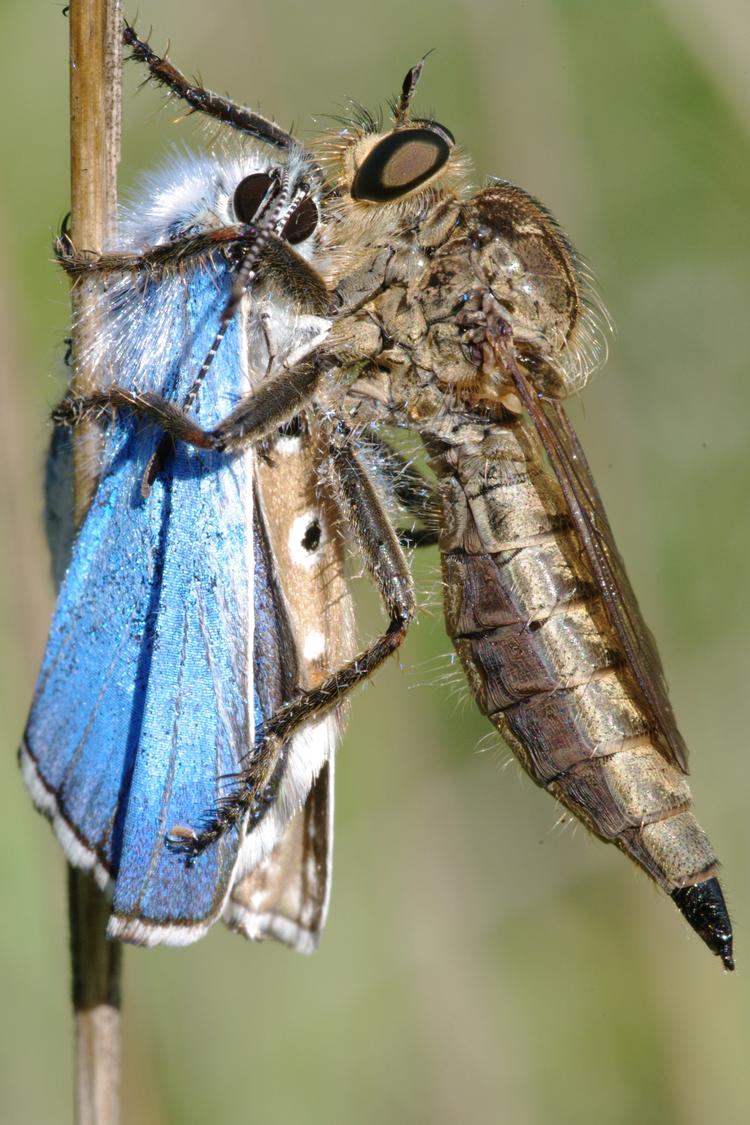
xmin=89 ymin=137 xmax=331 ymax=390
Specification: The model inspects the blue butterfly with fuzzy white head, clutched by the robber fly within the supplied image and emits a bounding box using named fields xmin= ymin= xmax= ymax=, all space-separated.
xmin=21 ymin=143 xmax=347 ymax=948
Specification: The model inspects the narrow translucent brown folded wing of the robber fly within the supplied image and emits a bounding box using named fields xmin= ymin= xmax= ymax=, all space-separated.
xmin=503 ymin=349 xmax=687 ymax=773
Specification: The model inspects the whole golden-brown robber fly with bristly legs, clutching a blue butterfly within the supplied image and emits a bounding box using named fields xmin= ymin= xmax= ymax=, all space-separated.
xmin=23 ymin=26 xmax=733 ymax=969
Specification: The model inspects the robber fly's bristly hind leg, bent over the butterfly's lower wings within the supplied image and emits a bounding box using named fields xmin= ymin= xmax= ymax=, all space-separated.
xmin=169 ymin=434 xmax=416 ymax=856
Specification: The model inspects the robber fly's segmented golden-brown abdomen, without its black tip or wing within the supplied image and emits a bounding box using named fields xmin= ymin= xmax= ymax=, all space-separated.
xmin=432 ymin=419 xmax=716 ymax=891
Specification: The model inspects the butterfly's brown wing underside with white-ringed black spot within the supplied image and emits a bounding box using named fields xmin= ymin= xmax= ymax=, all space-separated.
xmin=224 ymin=419 xmax=354 ymax=953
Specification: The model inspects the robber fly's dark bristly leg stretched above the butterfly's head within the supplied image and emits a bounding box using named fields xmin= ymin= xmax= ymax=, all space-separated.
xmin=123 ymin=24 xmax=293 ymax=149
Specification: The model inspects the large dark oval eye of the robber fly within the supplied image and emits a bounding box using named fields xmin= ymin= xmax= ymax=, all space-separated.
xmin=352 ymin=125 xmax=453 ymax=204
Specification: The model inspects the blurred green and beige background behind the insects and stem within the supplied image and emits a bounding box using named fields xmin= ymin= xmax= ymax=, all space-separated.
xmin=0 ymin=0 xmax=750 ymax=1125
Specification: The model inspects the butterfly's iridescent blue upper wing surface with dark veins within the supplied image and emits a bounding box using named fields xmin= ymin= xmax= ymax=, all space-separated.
xmin=22 ymin=266 xmax=254 ymax=943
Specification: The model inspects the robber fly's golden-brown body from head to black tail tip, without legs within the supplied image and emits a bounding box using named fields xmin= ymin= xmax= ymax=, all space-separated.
xmin=314 ymin=71 xmax=733 ymax=968
